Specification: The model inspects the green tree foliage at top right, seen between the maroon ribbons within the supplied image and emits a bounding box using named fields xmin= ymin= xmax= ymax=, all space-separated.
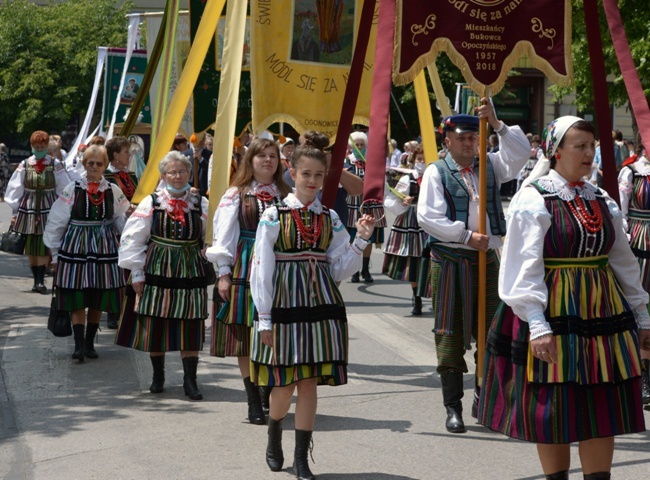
xmin=553 ymin=0 xmax=650 ymax=133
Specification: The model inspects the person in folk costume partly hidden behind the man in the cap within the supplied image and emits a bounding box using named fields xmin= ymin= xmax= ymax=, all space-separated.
xmin=381 ymin=145 xmax=428 ymax=315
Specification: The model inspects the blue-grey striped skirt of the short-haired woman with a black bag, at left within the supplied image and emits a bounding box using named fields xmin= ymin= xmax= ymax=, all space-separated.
xmin=55 ymin=220 xmax=125 ymax=313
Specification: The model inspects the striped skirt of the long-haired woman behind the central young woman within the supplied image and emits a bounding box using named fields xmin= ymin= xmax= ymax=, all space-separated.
xmin=210 ymin=230 xmax=255 ymax=357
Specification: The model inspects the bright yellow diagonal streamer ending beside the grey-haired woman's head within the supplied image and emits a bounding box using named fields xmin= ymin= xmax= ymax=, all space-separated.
xmin=132 ymin=0 xmax=228 ymax=203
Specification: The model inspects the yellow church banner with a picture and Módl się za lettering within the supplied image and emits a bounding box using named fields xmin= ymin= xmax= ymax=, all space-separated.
xmin=251 ymin=0 xmax=377 ymax=141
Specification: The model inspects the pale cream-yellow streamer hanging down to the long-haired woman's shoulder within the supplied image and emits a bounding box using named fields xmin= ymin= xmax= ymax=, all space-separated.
xmin=205 ymin=2 xmax=248 ymax=243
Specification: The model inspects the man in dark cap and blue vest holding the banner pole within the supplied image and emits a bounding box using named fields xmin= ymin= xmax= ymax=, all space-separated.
xmin=418 ymin=99 xmax=530 ymax=433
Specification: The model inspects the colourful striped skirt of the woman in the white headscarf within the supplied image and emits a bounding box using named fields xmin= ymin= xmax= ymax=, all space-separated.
xmin=478 ymin=259 xmax=645 ymax=444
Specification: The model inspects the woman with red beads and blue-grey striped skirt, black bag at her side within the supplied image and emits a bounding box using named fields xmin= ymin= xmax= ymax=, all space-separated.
xmin=44 ymin=145 xmax=129 ymax=362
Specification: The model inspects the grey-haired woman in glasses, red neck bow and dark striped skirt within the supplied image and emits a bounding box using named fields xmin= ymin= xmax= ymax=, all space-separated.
xmin=115 ymin=151 xmax=208 ymax=400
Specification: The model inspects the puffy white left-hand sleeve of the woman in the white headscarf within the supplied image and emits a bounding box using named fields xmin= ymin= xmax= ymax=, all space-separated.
xmin=499 ymin=187 xmax=551 ymax=322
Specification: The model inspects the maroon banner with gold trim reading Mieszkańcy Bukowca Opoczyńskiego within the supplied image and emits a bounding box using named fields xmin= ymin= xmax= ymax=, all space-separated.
xmin=393 ymin=0 xmax=573 ymax=94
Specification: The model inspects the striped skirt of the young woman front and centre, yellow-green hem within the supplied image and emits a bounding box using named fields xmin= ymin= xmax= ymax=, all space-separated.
xmin=251 ymin=252 xmax=348 ymax=386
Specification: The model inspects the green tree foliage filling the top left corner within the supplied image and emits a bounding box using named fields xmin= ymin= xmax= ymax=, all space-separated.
xmin=0 ymin=0 xmax=133 ymax=137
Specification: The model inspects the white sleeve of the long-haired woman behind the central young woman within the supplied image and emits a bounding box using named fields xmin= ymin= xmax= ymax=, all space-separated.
xmin=206 ymin=188 xmax=241 ymax=275
